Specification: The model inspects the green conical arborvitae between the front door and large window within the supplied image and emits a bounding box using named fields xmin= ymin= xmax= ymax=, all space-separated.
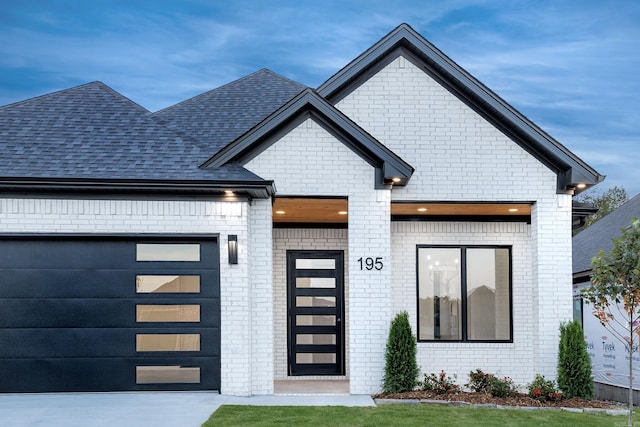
xmin=382 ymin=311 xmax=420 ymax=393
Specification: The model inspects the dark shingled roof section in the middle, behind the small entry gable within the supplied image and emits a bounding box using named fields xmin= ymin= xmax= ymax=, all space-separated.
xmin=153 ymin=69 xmax=306 ymax=156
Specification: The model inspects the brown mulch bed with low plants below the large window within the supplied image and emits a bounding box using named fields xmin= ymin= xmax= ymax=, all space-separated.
xmin=373 ymin=390 xmax=621 ymax=409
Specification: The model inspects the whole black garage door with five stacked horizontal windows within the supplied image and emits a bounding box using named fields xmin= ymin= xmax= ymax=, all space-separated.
xmin=0 ymin=236 xmax=220 ymax=392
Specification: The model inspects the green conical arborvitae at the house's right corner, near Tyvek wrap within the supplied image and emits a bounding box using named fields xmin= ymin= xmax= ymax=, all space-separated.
xmin=558 ymin=320 xmax=593 ymax=399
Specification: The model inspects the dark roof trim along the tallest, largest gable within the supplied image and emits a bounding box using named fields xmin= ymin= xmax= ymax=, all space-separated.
xmin=318 ymin=24 xmax=605 ymax=193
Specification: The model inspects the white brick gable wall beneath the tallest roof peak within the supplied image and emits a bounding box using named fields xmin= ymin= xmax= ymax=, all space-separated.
xmin=337 ymin=57 xmax=556 ymax=201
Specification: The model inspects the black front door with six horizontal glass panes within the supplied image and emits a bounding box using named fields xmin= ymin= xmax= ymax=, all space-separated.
xmin=287 ymin=251 xmax=344 ymax=375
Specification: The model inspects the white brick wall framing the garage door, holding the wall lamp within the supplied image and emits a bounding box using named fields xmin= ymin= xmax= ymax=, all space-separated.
xmin=0 ymin=198 xmax=254 ymax=395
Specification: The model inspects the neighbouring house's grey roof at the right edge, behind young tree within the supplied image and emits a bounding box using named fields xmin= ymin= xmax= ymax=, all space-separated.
xmin=573 ymin=194 xmax=640 ymax=281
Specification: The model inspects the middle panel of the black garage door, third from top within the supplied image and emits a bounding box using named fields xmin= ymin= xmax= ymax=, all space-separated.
xmin=0 ymin=298 xmax=219 ymax=328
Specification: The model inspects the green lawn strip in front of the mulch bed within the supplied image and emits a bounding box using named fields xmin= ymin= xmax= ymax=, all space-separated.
xmin=203 ymin=405 xmax=640 ymax=427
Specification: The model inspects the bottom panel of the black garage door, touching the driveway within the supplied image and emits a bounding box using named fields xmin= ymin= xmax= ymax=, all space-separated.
xmin=0 ymin=357 xmax=220 ymax=392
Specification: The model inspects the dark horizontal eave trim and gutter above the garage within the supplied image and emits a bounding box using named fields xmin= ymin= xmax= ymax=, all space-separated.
xmin=0 ymin=178 xmax=275 ymax=199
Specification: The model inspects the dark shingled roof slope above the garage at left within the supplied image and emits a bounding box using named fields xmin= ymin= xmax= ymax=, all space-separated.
xmin=0 ymin=82 xmax=260 ymax=181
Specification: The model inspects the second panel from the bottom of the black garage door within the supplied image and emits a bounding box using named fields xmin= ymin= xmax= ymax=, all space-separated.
xmin=0 ymin=328 xmax=220 ymax=358
